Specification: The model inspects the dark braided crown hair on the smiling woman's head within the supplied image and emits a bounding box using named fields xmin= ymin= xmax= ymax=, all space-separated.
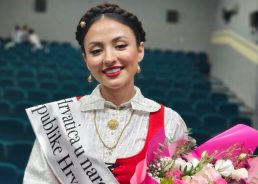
xmin=76 ymin=3 xmax=146 ymax=52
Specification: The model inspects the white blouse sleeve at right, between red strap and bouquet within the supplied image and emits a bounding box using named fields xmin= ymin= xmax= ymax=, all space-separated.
xmin=164 ymin=107 xmax=187 ymax=139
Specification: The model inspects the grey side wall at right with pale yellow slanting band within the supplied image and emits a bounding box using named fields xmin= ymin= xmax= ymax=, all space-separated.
xmin=210 ymin=0 xmax=258 ymax=125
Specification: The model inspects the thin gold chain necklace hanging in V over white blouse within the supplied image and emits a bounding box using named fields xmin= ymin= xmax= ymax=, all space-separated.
xmin=93 ymin=110 xmax=134 ymax=155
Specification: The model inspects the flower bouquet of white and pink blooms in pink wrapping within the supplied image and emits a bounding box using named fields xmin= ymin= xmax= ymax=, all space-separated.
xmin=131 ymin=124 xmax=258 ymax=184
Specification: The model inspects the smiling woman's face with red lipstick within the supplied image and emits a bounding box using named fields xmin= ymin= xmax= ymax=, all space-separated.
xmin=84 ymin=17 xmax=144 ymax=89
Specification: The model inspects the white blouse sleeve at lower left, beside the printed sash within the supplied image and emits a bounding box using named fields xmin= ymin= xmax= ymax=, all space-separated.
xmin=23 ymin=140 xmax=59 ymax=184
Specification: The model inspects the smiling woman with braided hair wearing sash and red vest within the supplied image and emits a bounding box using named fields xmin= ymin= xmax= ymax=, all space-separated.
xmin=24 ymin=3 xmax=187 ymax=184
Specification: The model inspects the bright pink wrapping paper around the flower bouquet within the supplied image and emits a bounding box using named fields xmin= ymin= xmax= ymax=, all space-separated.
xmin=130 ymin=124 xmax=258 ymax=184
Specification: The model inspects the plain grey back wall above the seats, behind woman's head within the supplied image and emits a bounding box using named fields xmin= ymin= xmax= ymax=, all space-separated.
xmin=0 ymin=0 xmax=215 ymax=51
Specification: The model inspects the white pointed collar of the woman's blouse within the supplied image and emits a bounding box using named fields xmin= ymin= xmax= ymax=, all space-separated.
xmin=79 ymin=85 xmax=160 ymax=112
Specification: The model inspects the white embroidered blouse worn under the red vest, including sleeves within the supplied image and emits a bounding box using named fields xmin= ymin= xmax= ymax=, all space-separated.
xmin=23 ymin=86 xmax=187 ymax=184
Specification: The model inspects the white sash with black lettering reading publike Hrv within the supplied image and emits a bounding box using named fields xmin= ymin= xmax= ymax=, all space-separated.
xmin=26 ymin=97 xmax=118 ymax=184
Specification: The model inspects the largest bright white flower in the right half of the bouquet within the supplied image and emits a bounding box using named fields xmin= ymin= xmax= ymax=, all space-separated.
xmin=215 ymin=160 xmax=234 ymax=177
